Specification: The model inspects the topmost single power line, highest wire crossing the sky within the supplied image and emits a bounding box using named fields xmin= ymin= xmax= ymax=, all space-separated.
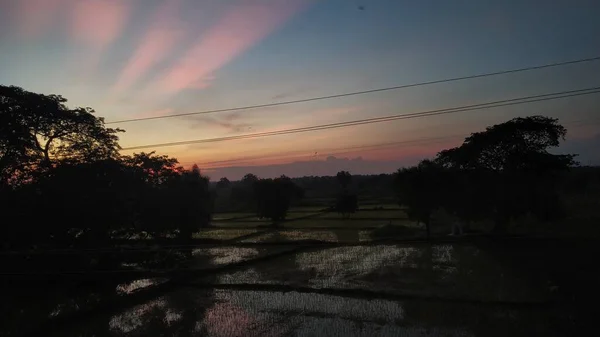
xmin=105 ymin=56 xmax=600 ymax=124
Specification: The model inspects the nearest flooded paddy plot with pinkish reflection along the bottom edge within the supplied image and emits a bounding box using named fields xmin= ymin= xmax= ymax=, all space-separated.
xmin=63 ymin=289 xmax=558 ymax=337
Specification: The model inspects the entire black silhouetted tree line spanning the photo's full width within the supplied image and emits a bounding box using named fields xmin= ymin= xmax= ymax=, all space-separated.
xmin=0 ymin=86 xmax=599 ymax=253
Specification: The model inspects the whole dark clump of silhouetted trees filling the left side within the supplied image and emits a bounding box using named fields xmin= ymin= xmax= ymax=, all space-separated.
xmin=0 ymin=86 xmax=213 ymax=246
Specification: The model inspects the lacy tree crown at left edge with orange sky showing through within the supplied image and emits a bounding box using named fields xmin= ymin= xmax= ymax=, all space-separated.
xmin=0 ymin=85 xmax=122 ymax=182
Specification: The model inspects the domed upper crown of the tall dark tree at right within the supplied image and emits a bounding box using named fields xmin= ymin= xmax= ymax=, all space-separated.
xmin=436 ymin=116 xmax=576 ymax=171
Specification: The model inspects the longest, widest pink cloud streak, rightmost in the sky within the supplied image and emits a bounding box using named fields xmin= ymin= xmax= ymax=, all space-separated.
xmin=160 ymin=0 xmax=308 ymax=92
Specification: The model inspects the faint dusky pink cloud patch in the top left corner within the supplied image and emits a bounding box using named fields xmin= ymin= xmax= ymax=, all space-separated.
xmin=17 ymin=0 xmax=66 ymax=37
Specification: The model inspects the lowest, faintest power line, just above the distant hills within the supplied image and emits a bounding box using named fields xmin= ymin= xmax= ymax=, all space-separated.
xmin=193 ymin=119 xmax=600 ymax=169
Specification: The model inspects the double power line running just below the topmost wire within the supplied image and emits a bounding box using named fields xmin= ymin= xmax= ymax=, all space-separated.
xmin=122 ymin=87 xmax=600 ymax=150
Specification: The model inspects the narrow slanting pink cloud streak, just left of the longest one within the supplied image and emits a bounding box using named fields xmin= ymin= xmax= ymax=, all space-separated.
xmin=114 ymin=0 xmax=183 ymax=90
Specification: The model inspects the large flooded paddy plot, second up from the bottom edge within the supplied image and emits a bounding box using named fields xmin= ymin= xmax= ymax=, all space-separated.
xmin=210 ymin=245 xmax=548 ymax=301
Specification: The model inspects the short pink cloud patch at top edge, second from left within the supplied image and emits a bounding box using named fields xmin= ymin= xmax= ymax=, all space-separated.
xmin=71 ymin=0 xmax=131 ymax=48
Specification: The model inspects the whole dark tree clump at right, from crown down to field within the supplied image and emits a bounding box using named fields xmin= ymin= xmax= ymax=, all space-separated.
xmin=396 ymin=116 xmax=576 ymax=233
